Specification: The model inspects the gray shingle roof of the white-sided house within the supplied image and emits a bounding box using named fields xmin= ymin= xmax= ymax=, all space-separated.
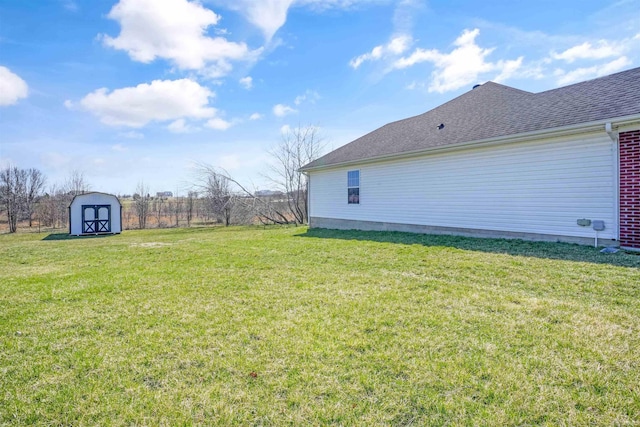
xmin=302 ymin=68 xmax=640 ymax=169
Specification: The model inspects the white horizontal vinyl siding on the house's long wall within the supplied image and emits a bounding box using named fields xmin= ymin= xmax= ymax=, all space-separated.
xmin=310 ymin=135 xmax=617 ymax=238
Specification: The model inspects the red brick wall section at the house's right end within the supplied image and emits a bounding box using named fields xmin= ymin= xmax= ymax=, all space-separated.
xmin=620 ymin=130 xmax=640 ymax=249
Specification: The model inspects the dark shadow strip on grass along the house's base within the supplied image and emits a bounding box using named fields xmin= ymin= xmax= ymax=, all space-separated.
xmin=297 ymin=228 xmax=640 ymax=268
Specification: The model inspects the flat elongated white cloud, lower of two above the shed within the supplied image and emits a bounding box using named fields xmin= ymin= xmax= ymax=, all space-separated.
xmin=80 ymin=79 xmax=217 ymax=128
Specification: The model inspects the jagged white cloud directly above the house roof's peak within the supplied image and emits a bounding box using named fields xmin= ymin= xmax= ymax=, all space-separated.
xmin=394 ymin=29 xmax=523 ymax=93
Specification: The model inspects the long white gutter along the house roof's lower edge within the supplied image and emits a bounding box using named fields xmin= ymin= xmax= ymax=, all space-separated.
xmin=300 ymin=114 xmax=640 ymax=172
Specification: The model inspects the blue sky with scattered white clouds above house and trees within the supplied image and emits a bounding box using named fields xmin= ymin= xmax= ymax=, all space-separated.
xmin=0 ymin=0 xmax=640 ymax=194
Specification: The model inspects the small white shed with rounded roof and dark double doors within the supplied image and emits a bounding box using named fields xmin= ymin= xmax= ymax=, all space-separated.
xmin=69 ymin=192 xmax=122 ymax=236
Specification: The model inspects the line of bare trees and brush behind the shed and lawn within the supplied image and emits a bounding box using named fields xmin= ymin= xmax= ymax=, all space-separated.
xmin=0 ymin=126 xmax=323 ymax=232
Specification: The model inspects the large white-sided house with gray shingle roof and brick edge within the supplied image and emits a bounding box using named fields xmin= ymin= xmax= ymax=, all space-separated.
xmin=300 ymin=68 xmax=640 ymax=250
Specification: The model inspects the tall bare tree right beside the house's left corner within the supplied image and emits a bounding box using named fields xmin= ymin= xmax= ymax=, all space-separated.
xmin=266 ymin=125 xmax=323 ymax=224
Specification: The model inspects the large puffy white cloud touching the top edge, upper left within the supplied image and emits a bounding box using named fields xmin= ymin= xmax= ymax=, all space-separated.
xmin=102 ymin=0 xmax=259 ymax=76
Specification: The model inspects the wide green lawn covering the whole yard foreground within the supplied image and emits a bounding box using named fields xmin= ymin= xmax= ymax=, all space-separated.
xmin=0 ymin=227 xmax=640 ymax=426
